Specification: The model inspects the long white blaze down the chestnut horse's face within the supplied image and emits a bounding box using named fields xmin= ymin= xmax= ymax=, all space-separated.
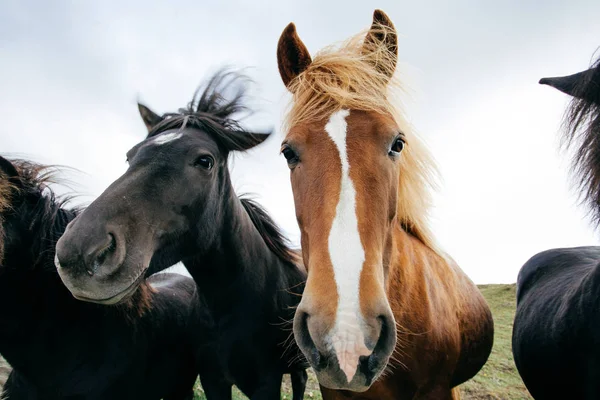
xmin=325 ymin=110 xmax=371 ymax=382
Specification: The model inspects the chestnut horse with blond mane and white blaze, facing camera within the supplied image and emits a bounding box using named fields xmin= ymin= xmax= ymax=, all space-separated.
xmin=277 ymin=10 xmax=493 ymax=400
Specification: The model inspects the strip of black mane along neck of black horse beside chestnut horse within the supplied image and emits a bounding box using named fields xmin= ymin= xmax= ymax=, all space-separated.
xmin=240 ymin=197 xmax=300 ymax=265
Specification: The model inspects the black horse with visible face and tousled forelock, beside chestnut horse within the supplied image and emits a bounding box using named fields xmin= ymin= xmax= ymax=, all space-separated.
xmin=57 ymin=72 xmax=307 ymax=400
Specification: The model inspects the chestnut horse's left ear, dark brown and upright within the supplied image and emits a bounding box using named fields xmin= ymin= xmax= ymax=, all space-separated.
xmin=277 ymin=22 xmax=312 ymax=88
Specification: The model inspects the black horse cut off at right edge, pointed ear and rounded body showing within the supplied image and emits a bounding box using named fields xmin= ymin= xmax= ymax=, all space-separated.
xmin=513 ymin=54 xmax=600 ymax=399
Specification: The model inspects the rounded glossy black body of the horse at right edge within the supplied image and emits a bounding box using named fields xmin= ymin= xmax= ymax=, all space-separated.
xmin=512 ymin=247 xmax=600 ymax=398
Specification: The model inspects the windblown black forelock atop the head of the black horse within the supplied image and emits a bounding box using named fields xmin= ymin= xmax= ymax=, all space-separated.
xmin=147 ymin=70 xmax=269 ymax=149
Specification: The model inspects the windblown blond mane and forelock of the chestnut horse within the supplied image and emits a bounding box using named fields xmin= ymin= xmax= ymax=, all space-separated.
xmin=284 ymin=25 xmax=437 ymax=251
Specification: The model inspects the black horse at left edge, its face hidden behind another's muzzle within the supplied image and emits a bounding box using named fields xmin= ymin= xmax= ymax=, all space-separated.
xmin=0 ymin=157 xmax=198 ymax=400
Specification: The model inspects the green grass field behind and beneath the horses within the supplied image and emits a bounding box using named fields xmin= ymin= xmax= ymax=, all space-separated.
xmin=0 ymin=285 xmax=531 ymax=400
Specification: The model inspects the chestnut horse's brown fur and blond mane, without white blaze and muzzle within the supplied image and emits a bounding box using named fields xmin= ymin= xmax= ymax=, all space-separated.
xmin=279 ymin=8 xmax=493 ymax=400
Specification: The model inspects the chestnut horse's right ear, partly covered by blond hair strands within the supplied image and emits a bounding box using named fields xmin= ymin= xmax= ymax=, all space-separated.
xmin=362 ymin=10 xmax=398 ymax=78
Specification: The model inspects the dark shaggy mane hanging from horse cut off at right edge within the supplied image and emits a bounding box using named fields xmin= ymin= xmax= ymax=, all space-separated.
xmin=563 ymin=58 xmax=600 ymax=226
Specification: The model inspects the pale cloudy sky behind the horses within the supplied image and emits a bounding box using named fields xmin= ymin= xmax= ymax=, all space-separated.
xmin=0 ymin=0 xmax=600 ymax=283
